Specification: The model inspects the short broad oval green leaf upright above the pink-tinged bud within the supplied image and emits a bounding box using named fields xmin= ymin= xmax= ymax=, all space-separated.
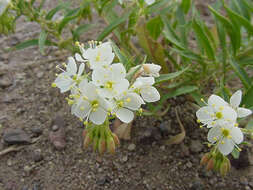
xmin=146 ymin=16 xmax=164 ymax=40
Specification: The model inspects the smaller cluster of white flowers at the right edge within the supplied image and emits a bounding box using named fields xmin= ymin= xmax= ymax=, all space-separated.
xmin=196 ymin=90 xmax=252 ymax=156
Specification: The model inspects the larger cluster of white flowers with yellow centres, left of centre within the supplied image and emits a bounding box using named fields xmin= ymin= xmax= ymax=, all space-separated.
xmin=53 ymin=42 xmax=160 ymax=125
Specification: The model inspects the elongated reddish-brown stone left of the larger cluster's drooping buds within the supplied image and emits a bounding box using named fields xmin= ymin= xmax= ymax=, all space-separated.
xmin=49 ymin=116 xmax=66 ymax=150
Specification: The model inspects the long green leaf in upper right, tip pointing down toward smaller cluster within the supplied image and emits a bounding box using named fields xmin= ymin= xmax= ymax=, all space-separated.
xmin=192 ymin=19 xmax=215 ymax=60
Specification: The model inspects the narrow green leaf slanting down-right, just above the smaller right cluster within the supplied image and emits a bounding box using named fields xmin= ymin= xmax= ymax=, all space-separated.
xmin=229 ymin=60 xmax=251 ymax=89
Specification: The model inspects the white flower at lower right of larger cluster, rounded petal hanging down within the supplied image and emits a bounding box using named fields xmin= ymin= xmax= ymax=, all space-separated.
xmin=112 ymin=92 xmax=145 ymax=123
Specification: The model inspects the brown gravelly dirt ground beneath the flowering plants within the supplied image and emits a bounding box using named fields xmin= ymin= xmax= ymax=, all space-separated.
xmin=0 ymin=1 xmax=253 ymax=190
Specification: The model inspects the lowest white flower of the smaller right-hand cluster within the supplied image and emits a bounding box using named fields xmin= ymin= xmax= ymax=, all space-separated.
xmin=207 ymin=124 xmax=243 ymax=156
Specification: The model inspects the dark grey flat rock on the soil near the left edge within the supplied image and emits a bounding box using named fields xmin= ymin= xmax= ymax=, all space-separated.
xmin=3 ymin=129 xmax=31 ymax=145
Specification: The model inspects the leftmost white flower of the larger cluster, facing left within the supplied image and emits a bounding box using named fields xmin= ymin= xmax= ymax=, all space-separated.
xmin=53 ymin=57 xmax=85 ymax=93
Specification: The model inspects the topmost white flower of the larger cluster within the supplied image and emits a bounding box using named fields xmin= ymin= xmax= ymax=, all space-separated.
xmin=80 ymin=42 xmax=114 ymax=69
